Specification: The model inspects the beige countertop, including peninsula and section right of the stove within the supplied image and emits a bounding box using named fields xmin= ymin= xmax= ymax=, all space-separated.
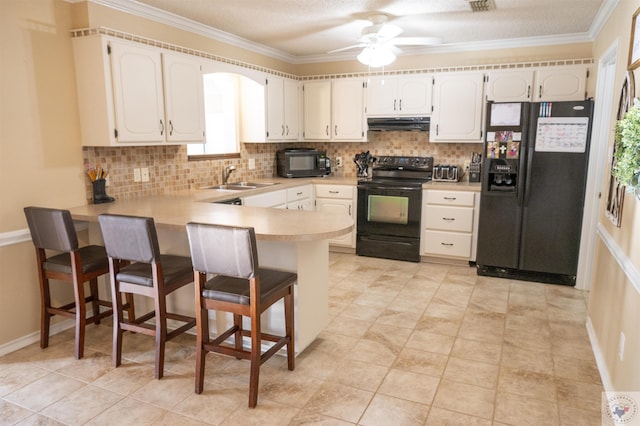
xmin=69 ymin=176 xmax=480 ymax=242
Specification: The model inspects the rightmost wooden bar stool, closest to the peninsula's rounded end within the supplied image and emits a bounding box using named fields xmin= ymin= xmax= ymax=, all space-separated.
xmin=187 ymin=223 xmax=297 ymax=408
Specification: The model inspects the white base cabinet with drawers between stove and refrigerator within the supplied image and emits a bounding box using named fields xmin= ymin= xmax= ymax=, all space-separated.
xmin=420 ymin=190 xmax=479 ymax=261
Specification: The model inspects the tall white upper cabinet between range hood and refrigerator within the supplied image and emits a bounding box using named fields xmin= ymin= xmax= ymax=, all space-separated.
xmin=429 ymin=72 xmax=484 ymax=143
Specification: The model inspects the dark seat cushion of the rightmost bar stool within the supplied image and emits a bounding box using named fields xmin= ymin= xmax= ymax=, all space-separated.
xmin=202 ymin=268 xmax=298 ymax=305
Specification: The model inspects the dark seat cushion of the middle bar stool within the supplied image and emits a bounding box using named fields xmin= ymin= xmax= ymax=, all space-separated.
xmin=116 ymin=254 xmax=193 ymax=287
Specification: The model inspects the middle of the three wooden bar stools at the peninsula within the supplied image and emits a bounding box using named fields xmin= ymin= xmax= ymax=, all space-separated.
xmin=98 ymin=214 xmax=196 ymax=379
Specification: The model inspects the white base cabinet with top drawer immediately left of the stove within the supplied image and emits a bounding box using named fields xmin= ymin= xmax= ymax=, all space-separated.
xmin=315 ymin=184 xmax=356 ymax=248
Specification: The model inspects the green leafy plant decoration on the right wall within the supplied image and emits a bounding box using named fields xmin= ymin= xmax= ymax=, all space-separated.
xmin=612 ymin=98 xmax=640 ymax=199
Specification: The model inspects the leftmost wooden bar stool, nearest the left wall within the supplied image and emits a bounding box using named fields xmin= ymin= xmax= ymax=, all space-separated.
xmin=24 ymin=206 xmax=113 ymax=359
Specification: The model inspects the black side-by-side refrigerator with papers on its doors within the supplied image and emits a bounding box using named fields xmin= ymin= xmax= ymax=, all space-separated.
xmin=476 ymin=100 xmax=593 ymax=285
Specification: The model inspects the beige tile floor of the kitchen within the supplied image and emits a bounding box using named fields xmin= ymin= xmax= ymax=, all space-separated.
xmin=0 ymin=253 xmax=602 ymax=426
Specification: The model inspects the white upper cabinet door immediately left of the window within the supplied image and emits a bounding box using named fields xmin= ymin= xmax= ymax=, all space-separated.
xmin=162 ymin=53 xmax=204 ymax=142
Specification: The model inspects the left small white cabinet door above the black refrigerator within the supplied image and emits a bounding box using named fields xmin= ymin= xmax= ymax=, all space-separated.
xmin=486 ymin=70 xmax=534 ymax=102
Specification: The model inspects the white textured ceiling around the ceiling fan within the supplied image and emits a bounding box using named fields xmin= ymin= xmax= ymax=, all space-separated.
xmin=107 ymin=0 xmax=608 ymax=61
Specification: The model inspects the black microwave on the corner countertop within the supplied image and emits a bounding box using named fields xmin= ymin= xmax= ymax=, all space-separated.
xmin=276 ymin=148 xmax=331 ymax=178
